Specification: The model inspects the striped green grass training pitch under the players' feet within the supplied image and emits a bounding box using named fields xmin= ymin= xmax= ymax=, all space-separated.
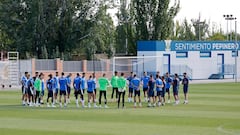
xmin=0 ymin=83 xmax=240 ymax=135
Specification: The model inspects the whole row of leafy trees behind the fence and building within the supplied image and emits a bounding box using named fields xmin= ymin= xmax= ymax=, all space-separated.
xmin=0 ymin=0 xmax=236 ymax=60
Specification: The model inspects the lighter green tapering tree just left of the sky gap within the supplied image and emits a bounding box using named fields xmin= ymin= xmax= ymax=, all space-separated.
xmin=77 ymin=2 xmax=115 ymax=59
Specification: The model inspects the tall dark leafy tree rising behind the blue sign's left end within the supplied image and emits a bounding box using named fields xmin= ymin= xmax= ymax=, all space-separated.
xmin=132 ymin=0 xmax=179 ymax=40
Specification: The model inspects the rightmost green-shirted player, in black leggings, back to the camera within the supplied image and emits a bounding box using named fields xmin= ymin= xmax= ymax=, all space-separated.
xmin=117 ymin=73 xmax=127 ymax=108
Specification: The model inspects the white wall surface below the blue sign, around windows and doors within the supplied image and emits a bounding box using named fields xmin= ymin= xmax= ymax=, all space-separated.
xmin=138 ymin=51 xmax=240 ymax=79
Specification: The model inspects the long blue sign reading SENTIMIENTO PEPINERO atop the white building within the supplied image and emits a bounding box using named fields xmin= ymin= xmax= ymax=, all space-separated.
xmin=137 ymin=40 xmax=240 ymax=52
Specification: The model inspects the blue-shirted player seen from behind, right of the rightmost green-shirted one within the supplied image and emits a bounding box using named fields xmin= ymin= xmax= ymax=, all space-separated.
xmin=131 ymin=74 xmax=142 ymax=107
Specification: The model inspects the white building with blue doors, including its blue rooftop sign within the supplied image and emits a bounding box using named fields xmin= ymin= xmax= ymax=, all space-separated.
xmin=137 ymin=40 xmax=240 ymax=79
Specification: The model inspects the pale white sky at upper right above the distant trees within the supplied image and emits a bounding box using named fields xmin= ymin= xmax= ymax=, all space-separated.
xmin=171 ymin=0 xmax=240 ymax=32
